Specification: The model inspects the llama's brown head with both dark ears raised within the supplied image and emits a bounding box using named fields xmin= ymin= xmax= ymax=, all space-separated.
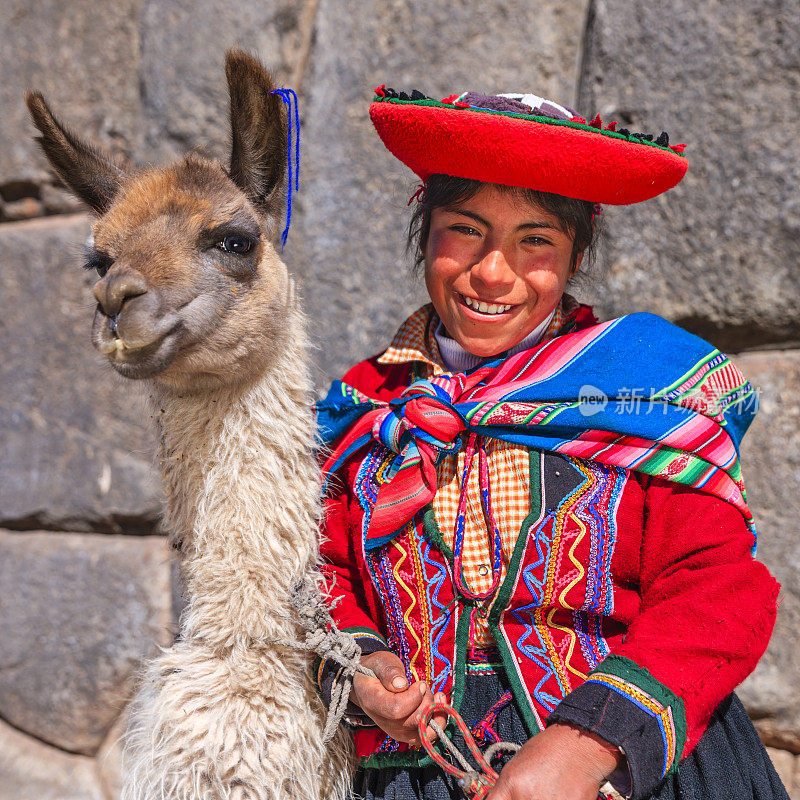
xmin=26 ymin=50 xmax=293 ymax=392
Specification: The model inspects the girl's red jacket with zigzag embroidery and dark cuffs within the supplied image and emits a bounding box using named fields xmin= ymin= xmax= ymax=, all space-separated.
xmin=316 ymin=304 xmax=778 ymax=797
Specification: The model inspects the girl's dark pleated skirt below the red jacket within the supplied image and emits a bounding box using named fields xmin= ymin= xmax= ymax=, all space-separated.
xmin=354 ymin=670 xmax=789 ymax=800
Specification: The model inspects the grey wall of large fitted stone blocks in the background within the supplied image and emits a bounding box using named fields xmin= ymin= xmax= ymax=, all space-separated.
xmin=0 ymin=0 xmax=800 ymax=800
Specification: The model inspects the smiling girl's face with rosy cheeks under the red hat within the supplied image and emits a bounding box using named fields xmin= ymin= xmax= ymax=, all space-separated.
xmin=424 ymin=185 xmax=582 ymax=358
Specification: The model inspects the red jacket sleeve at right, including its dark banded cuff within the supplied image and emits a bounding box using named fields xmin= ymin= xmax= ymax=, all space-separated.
xmin=548 ymin=478 xmax=780 ymax=800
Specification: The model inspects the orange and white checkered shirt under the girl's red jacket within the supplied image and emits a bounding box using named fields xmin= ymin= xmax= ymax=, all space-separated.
xmin=378 ymin=294 xmax=578 ymax=646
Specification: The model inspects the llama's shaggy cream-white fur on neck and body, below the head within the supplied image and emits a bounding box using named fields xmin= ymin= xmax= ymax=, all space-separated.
xmin=123 ymin=296 xmax=351 ymax=800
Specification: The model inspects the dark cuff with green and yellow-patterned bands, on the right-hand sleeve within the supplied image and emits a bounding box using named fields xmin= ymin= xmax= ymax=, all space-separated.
xmin=547 ymin=655 xmax=686 ymax=800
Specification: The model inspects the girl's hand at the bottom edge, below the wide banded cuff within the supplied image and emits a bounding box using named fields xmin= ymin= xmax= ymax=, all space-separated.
xmin=487 ymin=723 xmax=622 ymax=800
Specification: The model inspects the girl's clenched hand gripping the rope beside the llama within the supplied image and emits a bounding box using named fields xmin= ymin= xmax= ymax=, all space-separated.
xmin=352 ymin=652 xmax=445 ymax=746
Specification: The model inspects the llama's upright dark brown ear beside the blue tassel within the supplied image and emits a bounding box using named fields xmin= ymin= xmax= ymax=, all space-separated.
xmin=225 ymin=49 xmax=288 ymax=213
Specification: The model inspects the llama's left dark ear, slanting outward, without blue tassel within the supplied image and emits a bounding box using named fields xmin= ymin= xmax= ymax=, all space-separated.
xmin=25 ymin=92 xmax=125 ymax=214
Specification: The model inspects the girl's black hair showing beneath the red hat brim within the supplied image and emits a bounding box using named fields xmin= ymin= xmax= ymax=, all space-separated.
xmin=406 ymin=174 xmax=598 ymax=270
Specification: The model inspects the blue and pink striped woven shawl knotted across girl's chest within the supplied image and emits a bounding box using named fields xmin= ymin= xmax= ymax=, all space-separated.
xmin=317 ymin=314 xmax=757 ymax=549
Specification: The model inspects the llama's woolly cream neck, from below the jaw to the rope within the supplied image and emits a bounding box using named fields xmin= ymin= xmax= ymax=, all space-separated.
xmin=153 ymin=312 xmax=320 ymax=646
